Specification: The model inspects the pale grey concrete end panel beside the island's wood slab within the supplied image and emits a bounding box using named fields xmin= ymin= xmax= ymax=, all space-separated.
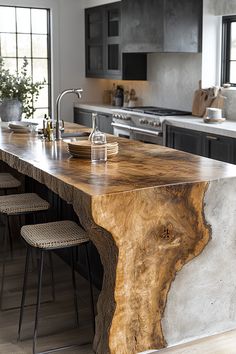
xmin=162 ymin=178 xmax=236 ymax=345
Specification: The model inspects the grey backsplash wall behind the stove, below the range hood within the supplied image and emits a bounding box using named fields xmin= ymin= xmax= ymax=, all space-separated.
xmin=83 ymin=53 xmax=201 ymax=110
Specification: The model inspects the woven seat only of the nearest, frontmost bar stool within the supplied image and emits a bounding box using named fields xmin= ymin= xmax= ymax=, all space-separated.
xmin=21 ymin=220 xmax=89 ymax=250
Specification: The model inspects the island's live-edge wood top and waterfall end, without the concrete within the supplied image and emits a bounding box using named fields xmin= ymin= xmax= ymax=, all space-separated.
xmin=0 ymin=124 xmax=236 ymax=354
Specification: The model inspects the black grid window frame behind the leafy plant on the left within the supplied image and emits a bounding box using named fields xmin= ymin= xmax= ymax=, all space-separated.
xmin=0 ymin=5 xmax=52 ymax=116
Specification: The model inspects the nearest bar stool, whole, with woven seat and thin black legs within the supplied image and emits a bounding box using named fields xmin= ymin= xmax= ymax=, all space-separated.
xmin=18 ymin=220 xmax=95 ymax=354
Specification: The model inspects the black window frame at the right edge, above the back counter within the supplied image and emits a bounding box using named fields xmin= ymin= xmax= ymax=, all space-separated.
xmin=221 ymin=15 xmax=236 ymax=87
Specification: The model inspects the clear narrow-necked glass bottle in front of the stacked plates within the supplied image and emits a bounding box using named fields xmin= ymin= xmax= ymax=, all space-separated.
xmin=89 ymin=113 xmax=107 ymax=163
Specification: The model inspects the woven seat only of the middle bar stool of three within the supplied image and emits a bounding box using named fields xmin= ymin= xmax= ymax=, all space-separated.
xmin=0 ymin=193 xmax=50 ymax=215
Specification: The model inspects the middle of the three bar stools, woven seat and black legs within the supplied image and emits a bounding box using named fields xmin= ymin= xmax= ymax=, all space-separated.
xmin=0 ymin=193 xmax=50 ymax=310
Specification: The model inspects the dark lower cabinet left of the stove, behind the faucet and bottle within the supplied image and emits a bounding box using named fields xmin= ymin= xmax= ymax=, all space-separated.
xmin=74 ymin=107 xmax=113 ymax=134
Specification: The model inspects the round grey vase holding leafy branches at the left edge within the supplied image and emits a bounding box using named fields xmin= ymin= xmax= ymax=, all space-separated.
xmin=0 ymin=99 xmax=23 ymax=122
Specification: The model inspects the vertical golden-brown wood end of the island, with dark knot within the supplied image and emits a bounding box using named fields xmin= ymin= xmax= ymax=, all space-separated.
xmin=91 ymin=183 xmax=210 ymax=354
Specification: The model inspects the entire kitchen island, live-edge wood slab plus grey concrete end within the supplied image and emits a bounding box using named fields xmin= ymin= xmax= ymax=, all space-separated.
xmin=0 ymin=124 xmax=236 ymax=354
